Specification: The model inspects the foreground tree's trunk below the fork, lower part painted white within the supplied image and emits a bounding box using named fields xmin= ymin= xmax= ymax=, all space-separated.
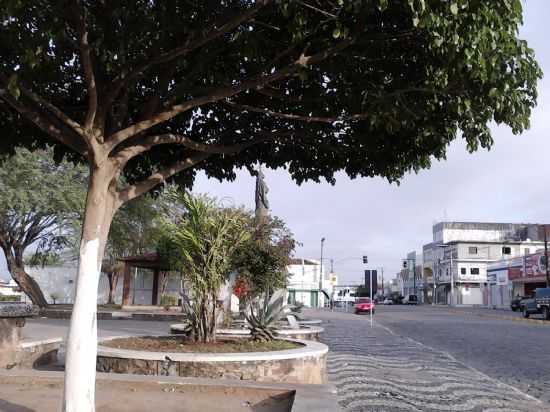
xmin=63 ymin=170 xmax=115 ymax=412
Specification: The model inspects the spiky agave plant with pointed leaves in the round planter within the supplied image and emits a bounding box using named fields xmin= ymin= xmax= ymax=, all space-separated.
xmin=245 ymin=290 xmax=285 ymax=342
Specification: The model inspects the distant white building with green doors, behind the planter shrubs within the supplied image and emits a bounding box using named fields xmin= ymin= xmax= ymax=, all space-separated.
xmin=287 ymin=258 xmax=337 ymax=308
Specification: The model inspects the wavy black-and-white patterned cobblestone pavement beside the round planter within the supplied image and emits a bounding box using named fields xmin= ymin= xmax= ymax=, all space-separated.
xmin=313 ymin=311 xmax=550 ymax=412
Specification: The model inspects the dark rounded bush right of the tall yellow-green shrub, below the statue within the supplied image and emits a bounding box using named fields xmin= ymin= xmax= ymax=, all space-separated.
xmin=233 ymin=217 xmax=296 ymax=299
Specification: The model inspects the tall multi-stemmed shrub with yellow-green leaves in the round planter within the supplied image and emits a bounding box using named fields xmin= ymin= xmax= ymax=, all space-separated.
xmin=159 ymin=192 xmax=250 ymax=342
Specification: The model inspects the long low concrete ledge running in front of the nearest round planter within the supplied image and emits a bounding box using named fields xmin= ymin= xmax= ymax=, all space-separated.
xmin=0 ymin=369 xmax=340 ymax=412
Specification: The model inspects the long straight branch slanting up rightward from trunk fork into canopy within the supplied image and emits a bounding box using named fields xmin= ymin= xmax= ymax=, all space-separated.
xmin=108 ymin=40 xmax=352 ymax=152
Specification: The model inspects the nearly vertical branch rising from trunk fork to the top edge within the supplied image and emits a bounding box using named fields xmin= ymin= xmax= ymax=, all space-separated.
xmin=74 ymin=0 xmax=97 ymax=130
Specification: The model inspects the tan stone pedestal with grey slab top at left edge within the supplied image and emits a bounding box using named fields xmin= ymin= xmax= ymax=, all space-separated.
xmin=0 ymin=302 xmax=35 ymax=368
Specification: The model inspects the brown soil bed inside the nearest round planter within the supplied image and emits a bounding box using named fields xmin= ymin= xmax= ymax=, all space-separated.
xmin=101 ymin=336 xmax=302 ymax=353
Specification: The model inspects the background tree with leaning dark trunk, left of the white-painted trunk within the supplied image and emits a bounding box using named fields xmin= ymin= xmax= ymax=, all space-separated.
xmin=0 ymin=149 xmax=86 ymax=307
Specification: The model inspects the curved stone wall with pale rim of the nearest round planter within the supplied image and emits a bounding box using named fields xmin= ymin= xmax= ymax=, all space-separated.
xmin=97 ymin=337 xmax=328 ymax=384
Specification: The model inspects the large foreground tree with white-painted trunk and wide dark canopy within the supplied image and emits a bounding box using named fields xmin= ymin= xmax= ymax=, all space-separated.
xmin=0 ymin=0 xmax=541 ymax=412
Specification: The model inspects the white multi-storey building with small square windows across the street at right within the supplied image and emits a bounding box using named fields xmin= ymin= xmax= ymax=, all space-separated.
xmin=422 ymin=222 xmax=544 ymax=305
